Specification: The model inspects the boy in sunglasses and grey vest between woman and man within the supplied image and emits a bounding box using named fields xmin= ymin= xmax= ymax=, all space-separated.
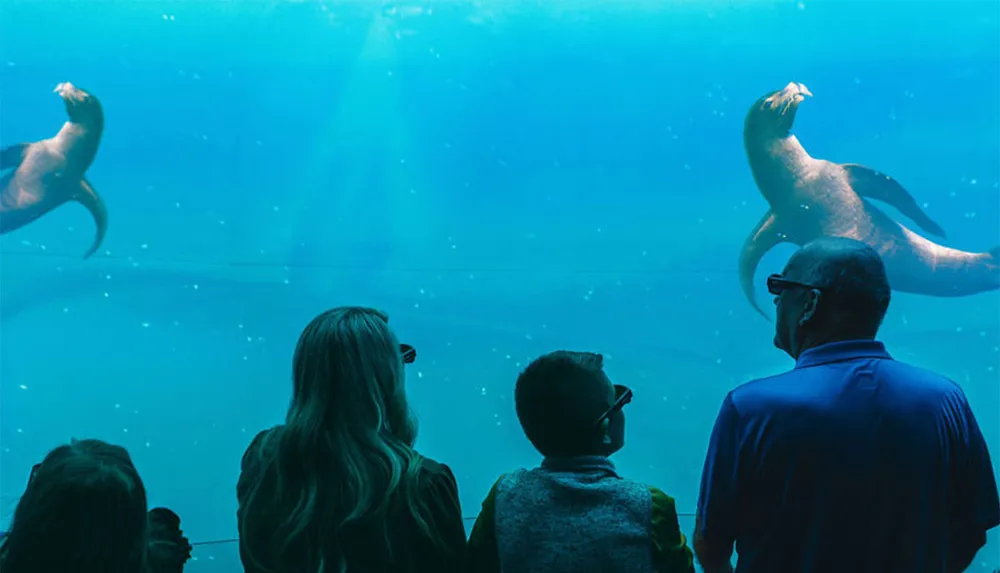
xmin=468 ymin=350 xmax=694 ymax=573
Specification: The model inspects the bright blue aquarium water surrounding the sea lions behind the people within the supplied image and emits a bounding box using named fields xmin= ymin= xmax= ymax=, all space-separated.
xmin=0 ymin=0 xmax=1000 ymax=573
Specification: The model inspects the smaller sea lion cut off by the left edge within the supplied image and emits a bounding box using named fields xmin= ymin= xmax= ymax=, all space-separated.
xmin=0 ymin=82 xmax=108 ymax=258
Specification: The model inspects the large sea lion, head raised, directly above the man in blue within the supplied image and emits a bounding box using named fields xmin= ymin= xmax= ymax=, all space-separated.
xmin=739 ymin=82 xmax=1000 ymax=318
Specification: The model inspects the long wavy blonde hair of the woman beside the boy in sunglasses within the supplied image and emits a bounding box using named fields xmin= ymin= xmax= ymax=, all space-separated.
xmin=240 ymin=307 xmax=433 ymax=573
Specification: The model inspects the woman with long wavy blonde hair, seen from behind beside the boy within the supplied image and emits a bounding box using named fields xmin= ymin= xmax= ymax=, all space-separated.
xmin=237 ymin=307 xmax=465 ymax=573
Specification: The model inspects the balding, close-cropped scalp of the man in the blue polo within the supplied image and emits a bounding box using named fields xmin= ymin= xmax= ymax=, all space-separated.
xmin=784 ymin=237 xmax=891 ymax=337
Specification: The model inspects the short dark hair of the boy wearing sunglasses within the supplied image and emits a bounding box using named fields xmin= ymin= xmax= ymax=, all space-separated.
xmin=514 ymin=350 xmax=610 ymax=457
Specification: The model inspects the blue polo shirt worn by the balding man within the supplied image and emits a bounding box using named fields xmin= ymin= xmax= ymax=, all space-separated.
xmin=697 ymin=340 xmax=1000 ymax=573
